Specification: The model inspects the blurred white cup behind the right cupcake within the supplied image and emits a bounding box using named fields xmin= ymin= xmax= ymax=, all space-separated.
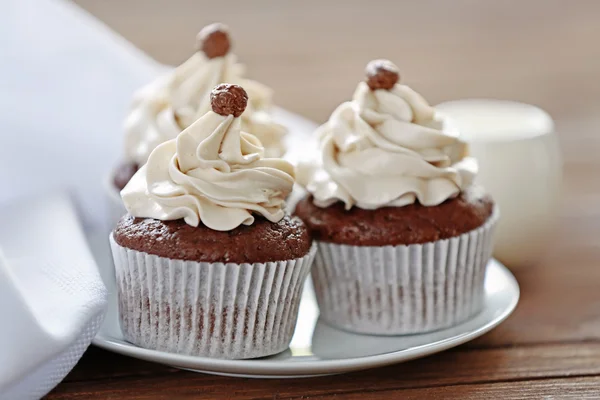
xmin=436 ymin=99 xmax=562 ymax=268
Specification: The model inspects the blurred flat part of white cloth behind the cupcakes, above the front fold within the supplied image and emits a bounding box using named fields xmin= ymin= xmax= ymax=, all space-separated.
xmin=0 ymin=0 xmax=166 ymax=230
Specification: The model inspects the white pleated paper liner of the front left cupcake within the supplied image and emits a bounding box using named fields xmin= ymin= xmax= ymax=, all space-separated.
xmin=110 ymin=235 xmax=317 ymax=359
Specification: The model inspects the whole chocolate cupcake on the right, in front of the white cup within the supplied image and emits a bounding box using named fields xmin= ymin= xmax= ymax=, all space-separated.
xmin=295 ymin=60 xmax=498 ymax=334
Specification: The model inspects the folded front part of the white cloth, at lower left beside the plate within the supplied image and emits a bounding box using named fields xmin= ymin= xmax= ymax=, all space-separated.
xmin=0 ymin=194 xmax=107 ymax=400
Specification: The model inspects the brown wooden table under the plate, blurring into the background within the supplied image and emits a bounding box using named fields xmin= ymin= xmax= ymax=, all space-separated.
xmin=48 ymin=0 xmax=600 ymax=400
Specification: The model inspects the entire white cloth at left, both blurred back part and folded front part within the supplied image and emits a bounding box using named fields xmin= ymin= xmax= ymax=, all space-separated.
xmin=0 ymin=0 xmax=155 ymax=400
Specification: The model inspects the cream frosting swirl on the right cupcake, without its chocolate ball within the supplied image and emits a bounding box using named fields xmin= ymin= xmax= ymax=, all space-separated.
xmin=297 ymin=78 xmax=477 ymax=209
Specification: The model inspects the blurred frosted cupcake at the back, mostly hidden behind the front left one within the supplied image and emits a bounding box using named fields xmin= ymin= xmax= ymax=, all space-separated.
xmin=109 ymin=23 xmax=287 ymax=225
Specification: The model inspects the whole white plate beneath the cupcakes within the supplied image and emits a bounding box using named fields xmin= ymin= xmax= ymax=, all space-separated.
xmin=90 ymin=231 xmax=519 ymax=378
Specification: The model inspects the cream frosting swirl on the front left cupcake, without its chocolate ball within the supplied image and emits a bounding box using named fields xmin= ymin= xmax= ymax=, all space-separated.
xmin=121 ymin=111 xmax=294 ymax=231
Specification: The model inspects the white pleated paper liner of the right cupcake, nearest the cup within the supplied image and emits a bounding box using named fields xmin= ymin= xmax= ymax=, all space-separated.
xmin=311 ymin=208 xmax=499 ymax=335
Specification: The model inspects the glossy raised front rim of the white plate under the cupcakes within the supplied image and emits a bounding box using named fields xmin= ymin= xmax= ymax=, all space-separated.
xmin=92 ymin=259 xmax=520 ymax=377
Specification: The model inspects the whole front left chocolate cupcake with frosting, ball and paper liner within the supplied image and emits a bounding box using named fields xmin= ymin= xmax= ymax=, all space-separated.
xmin=110 ymin=84 xmax=316 ymax=359
